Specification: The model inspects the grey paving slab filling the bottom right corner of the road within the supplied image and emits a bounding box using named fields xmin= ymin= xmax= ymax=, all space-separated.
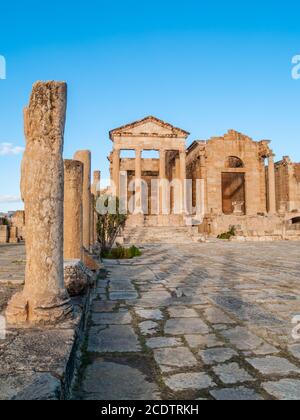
xmin=262 ymin=379 xmax=300 ymax=401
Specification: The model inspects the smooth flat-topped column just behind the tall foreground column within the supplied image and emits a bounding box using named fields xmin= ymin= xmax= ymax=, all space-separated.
xmin=64 ymin=160 xmax=83 ymax=260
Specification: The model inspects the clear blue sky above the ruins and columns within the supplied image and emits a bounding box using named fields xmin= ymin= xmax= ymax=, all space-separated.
xmin=0 ymin=0 xmax=300 ymax=211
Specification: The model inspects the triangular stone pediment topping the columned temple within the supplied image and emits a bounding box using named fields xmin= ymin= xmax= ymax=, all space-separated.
xmin=110 ymin=117 xmax=189 ymax=140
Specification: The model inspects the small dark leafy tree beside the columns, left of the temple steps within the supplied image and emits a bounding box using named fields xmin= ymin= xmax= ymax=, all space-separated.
xmin=96 ymin=195 xmax=127 ymax=255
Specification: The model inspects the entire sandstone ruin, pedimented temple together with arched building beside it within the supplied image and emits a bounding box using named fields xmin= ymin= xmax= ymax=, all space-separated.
xmin=109 ymin=117 xmax=300 ymax=238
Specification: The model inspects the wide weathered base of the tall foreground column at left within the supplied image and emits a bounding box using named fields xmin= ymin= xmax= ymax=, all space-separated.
xmin=6 ymin=290 xmax=73 ymax=325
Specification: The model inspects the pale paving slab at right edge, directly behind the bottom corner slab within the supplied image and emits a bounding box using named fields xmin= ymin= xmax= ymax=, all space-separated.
xmin=246 ymin=356 xmax=300 ymax=376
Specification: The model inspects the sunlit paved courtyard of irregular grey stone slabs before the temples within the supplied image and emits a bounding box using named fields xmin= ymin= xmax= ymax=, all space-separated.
xmin=75 ymin=242 xmax=300 ymax=400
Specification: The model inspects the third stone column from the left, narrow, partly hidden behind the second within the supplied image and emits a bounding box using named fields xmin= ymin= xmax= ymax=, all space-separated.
xmin=74 ymin=150 xmax=91 ymax=250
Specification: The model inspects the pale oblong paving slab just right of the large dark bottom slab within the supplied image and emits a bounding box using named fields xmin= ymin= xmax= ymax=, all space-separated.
xmin=164 ymin=372 xmax=216 ymax=392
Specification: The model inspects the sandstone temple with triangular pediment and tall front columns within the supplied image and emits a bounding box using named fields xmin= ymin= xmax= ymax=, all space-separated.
xmin=109 ymin=117 xmax=189 ymax=225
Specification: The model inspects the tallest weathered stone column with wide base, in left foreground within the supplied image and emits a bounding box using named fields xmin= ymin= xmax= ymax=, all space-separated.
xmin=6 ymin=82 xmax=73 ymax=324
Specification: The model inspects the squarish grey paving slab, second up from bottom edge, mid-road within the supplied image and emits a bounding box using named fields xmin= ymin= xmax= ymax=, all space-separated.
xmin=154 ymin=347 xmax=198 ymax=368
